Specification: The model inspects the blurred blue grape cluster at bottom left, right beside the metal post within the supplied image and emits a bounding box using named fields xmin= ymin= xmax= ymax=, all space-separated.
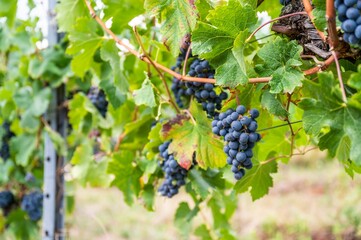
xmin=21 ymin=191 xmax=43 ymax=221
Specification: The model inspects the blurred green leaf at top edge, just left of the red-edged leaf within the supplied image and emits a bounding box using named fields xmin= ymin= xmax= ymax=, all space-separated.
xmin=103 ymin=0 xmax=143 ymax=33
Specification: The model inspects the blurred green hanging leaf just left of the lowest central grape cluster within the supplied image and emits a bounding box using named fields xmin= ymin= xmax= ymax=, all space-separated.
xmin=108 ymin=151 xmax=142 ymax=205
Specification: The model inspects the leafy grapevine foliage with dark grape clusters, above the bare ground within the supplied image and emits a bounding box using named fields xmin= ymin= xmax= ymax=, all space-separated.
xmin=0 ymin=0 xmax=361 ymax=239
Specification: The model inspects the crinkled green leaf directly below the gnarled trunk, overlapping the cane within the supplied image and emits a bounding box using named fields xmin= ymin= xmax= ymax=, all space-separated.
xmin=256 ymin=37 xmax=303 ymax=93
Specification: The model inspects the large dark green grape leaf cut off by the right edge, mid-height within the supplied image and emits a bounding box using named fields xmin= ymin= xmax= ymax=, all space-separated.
xmin=299 ymin=73 xmax=361 ymax=165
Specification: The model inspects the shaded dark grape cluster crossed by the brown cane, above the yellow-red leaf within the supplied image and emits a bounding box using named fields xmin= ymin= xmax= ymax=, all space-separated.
xmin=171 ymin=58 xmax=228 ymax=117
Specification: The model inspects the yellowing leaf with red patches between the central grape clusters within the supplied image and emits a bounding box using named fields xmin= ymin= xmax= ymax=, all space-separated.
xmin=161 ymin=101 xmax=226 ymax=169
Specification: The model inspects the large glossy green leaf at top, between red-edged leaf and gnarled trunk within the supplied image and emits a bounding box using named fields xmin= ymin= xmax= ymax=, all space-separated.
xmin=192 ymin=0 xmax=257 ymax=88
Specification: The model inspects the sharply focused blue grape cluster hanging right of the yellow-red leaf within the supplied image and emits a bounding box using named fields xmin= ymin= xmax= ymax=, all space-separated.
xmin=212 ymin=105 xmax=261 ymax=180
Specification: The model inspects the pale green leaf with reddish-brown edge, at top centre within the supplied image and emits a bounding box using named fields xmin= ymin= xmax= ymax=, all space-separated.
xmin=144 ymin=0 xmax=197 ymax=56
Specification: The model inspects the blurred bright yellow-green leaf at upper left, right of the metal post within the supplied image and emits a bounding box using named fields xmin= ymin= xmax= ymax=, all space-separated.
xmin=66 ymin=18 xmax=103 ymax=77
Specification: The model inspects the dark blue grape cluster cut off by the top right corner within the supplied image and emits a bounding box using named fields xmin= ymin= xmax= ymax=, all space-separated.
xmin=335 ymin=0 xmax=361 ymax=47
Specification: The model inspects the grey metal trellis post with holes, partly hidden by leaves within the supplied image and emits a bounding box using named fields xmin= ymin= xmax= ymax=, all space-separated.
xmin=42 ymin=0 xmax=67 ymax=240
